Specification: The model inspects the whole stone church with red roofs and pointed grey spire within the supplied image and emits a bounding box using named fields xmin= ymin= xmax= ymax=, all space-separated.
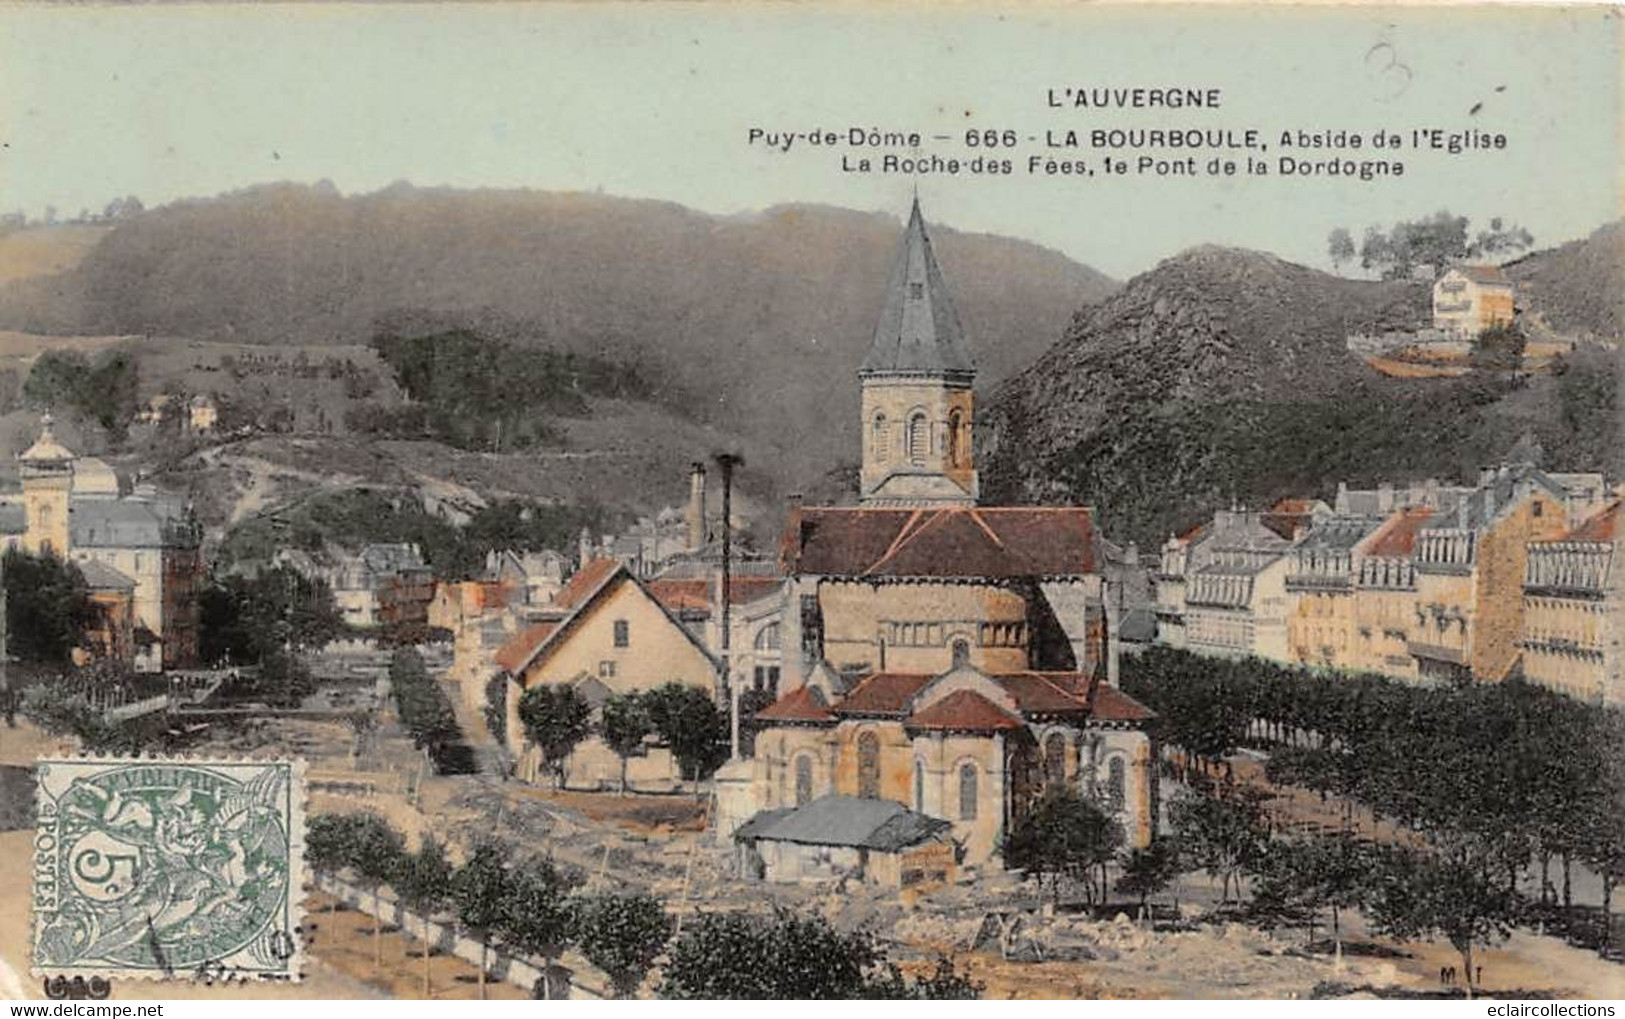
xmin=731 ymin=202 xmax=1157 ymax=882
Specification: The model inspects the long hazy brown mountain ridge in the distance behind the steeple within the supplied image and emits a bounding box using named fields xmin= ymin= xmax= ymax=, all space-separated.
xmin=0 ymin=185 xmax=1112 ymax=497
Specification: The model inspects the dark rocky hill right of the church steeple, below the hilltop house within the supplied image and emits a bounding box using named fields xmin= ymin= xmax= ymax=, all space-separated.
xmin=978 ymin=247 xmax=1619 ymax=546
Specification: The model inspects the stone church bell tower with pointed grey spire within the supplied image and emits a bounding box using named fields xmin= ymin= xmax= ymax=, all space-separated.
xmin=858 ymin=198 xmax=978 ymax=507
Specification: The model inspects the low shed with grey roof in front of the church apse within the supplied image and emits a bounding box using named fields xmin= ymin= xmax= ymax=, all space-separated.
xmin=733 ymin=795 xmax=957 ymax=887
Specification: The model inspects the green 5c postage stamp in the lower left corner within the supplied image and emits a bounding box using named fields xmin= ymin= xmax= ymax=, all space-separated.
xmin=31 ymin=757 xmax=304 ymax=980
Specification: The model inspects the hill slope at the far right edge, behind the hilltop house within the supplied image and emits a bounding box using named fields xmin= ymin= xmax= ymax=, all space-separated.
xmin=1505 ymin=219 xmax=1625 ymax=340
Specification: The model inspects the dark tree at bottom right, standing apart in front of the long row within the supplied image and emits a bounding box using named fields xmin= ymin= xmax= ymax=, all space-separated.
xmin=1372 ymin=848 xmax=1518 ymax=998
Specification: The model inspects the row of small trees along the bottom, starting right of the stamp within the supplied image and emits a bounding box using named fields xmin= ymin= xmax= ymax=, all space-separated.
xmin=306 ymin=814 xmax=980 ymax=998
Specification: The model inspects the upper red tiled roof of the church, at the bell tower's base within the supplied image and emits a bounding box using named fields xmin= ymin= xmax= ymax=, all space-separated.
xmin=783 ymin=507 xmax=1099 ymax=579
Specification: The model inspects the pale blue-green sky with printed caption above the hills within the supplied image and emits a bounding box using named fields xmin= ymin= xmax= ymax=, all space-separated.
xmin=0 ymin=3 xmax=1622 ymax=276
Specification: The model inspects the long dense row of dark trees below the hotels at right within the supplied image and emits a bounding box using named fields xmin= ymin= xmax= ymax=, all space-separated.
xmin=1123 ymin=648 xmax=1625 ymax=962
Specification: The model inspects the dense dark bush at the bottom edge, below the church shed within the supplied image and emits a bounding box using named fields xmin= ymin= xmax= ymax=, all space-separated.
xmin=660 ymin=908 xmax=982 ymax=1001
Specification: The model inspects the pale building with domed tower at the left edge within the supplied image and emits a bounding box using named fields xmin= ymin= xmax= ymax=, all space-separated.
xmin=0 ymin=414 xmax=203 ymax=671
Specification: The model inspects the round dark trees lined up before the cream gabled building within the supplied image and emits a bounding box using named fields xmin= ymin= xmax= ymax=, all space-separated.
xmin=507 ymin=674 xmax=728 ymax=793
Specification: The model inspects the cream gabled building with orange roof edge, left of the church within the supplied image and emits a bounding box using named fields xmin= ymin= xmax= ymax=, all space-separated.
xmin=496 ymin=559 xmax=720 ymax=788
